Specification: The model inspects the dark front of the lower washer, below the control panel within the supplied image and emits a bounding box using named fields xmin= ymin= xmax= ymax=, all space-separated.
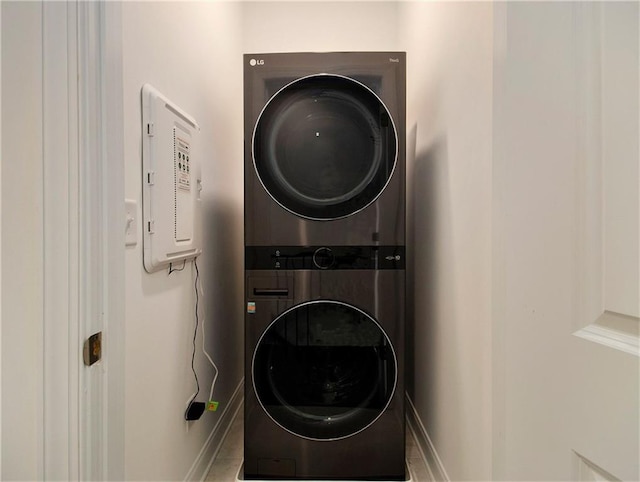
xmin=244 ymin=269 xmax=405 ymax=480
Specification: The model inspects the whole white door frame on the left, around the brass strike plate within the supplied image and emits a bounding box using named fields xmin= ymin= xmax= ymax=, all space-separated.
xmin=42 ymin=1 xmax=125 ymax=480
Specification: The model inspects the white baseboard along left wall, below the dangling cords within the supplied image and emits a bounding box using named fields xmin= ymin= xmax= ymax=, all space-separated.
xmin=184 ymin=378 xmax=244 ymax=482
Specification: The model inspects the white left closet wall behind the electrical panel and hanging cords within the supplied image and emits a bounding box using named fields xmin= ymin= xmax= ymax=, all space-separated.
xmin=122 ymin=2 xmax=243 ymax=480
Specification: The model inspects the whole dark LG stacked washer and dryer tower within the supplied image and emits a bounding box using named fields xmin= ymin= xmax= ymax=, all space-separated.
xmin=244 ymin=52 xmax=406 ymax=480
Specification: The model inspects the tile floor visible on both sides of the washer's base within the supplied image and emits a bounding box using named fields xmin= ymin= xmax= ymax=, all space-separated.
xmin=205 ymin=409 xmax=432 ymax=482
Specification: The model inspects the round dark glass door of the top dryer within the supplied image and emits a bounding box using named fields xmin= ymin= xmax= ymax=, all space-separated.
xmin=253 ymin=74 xmax=398 ymax=220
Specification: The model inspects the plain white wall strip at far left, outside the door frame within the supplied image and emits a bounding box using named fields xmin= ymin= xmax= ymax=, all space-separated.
xmin=0 ymin=2 xmax=43 ymax=480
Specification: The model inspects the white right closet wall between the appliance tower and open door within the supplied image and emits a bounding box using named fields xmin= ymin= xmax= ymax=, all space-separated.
xmin=398 ymin=2 xmax=493 ymax=480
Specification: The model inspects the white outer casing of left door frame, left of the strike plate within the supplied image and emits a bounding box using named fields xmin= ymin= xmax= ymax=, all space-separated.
xmin=41 ymin=2 xmax=80 ymax=480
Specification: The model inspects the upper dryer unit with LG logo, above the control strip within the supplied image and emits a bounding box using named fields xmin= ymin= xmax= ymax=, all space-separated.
xmin=244 ymin=52 xmax=406 ymax=246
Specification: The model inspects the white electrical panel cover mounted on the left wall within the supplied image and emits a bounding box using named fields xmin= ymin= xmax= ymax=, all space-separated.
xmin=142 ymin=84 xmax=202 ymax=273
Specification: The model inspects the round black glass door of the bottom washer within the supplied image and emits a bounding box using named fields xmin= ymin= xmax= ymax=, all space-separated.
xmin=252 ymin=300 xmax=397 ymax=440
